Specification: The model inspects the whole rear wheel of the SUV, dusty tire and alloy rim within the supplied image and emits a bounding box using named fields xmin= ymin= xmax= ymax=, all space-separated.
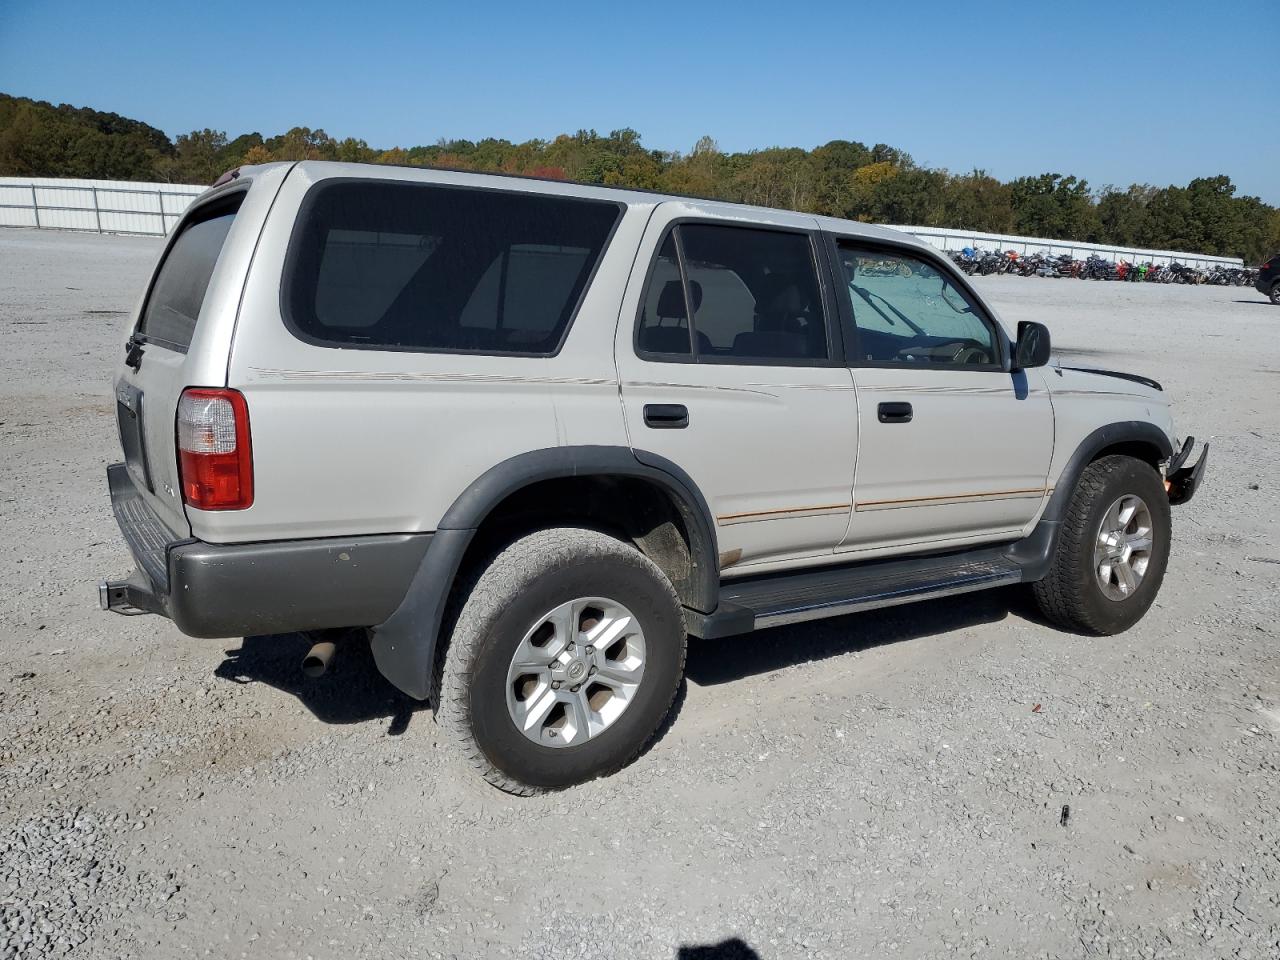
xmin=436 ymin=527 xmax=685 ymax=795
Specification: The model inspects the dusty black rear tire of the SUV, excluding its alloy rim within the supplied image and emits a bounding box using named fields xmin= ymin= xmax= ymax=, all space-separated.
xmin=435 ymin=527 xmax=685 ymax=796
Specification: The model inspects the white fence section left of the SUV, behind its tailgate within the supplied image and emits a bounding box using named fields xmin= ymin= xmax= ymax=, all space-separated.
xmin=0 ymin=177 xmax=206 ymax=237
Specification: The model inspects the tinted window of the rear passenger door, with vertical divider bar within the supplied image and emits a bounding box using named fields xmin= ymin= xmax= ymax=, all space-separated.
xmin=636 ymin=223 xmax=829 ymax=365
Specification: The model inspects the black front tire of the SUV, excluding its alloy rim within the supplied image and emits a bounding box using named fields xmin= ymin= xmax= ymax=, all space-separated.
xmin=1032 ymin=456 xmax=1171 ymax=636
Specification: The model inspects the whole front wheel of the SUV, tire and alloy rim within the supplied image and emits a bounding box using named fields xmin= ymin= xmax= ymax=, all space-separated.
xmin=1032 ymin=456 xmax=1171 ymax=635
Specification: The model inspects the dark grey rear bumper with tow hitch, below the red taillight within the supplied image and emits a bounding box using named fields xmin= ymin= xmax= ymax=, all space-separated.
xmin=99 ymin=463 xmax=431 ymax=637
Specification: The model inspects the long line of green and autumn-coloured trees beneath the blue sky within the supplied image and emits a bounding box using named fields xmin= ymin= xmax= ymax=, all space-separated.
xmin=0 ymin=93 xmax=1280 ymax=264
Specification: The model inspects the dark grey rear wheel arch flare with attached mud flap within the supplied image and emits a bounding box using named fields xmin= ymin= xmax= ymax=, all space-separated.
xmin=370 ymin=445 xmax=719 ymax=700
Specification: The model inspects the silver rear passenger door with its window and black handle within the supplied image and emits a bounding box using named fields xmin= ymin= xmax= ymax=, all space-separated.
xmin=616 ymin=202 xmax=858 ymax=575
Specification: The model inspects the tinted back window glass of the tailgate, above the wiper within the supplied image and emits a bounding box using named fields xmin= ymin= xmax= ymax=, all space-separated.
xmin=138 ymin=192 xmax=244 ymax=351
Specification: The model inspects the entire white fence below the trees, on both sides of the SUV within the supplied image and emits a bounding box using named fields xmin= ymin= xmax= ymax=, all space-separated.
xmin=0 ymin=177 xmax=1243 ymax=268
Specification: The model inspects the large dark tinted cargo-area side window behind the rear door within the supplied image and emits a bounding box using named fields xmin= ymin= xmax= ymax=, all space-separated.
xmin=283 ymin=180 xmax=621 ymax=355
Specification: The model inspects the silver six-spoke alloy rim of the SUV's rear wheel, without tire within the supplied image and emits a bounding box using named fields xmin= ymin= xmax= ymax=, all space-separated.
xmin=507 ymin=596 xmax=645 ymax=748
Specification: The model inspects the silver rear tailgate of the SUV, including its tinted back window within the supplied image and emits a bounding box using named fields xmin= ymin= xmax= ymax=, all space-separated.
xmin=115 ymin=188 xmax=247 ymax=536
